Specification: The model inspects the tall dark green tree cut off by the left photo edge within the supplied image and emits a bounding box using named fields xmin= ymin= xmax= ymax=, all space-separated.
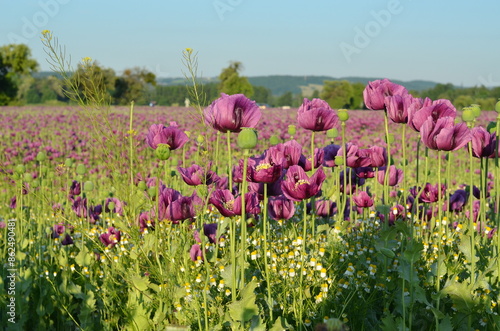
xmin=0 ymin=44 xmax=38 ymax=105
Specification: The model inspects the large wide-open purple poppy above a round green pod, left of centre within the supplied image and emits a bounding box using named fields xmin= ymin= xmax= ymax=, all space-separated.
xmin=203 ymin=93 xmax=261 ymax=132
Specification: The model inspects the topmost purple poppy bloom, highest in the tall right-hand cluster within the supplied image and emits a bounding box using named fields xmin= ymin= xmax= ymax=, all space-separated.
xmin=363 ymin=78 xmax=408 ymax=110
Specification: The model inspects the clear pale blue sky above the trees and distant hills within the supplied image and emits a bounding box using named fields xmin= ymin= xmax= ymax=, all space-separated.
xmin=0 ymin=0 xmax=500 ymax=86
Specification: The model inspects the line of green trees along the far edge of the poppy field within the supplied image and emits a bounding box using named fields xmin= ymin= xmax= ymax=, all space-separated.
xmin=0 ymin=44 xmax=500 ymax=110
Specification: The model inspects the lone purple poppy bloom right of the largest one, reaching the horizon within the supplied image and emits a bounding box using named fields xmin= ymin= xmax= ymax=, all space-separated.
xmin=297 ymin=98 xmax=339 ymax=131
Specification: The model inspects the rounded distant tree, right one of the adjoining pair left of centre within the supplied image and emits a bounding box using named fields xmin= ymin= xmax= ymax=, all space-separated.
xmin=113 ymin=67 xmax=156 ymax=105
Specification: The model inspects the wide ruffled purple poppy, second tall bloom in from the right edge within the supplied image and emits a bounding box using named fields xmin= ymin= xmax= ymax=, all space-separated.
xmin=420 ymin=116 xmax=472 ymax=151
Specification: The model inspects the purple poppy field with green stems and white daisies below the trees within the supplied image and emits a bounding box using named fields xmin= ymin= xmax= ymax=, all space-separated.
xmin=0 ymin=52 xmax=500 ymax=330
